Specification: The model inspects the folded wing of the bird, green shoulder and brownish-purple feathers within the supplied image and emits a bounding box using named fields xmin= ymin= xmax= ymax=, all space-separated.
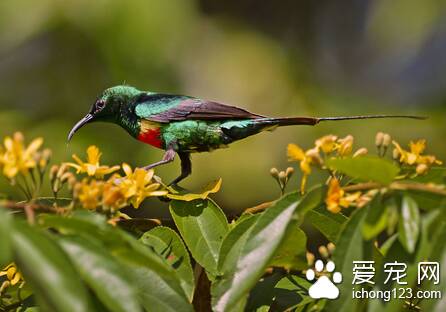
xmin=135 ymin=93 xmax=263 ymax=123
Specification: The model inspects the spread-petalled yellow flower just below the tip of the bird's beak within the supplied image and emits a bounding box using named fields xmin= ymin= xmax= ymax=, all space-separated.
xmin=67 ymin=145 xmax=119 ymax=178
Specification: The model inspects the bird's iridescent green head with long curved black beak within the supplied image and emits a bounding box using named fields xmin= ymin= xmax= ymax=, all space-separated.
xmin=68 ymin=86 xmax=141 ymax=141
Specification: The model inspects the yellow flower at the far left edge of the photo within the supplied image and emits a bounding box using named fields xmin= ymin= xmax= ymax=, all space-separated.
xmin=0 ymin=132 xmax=43 ymax=179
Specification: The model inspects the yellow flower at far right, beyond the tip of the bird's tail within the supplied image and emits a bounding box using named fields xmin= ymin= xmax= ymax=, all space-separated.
xmin=392 ymin=139 xmax=442 ymax=166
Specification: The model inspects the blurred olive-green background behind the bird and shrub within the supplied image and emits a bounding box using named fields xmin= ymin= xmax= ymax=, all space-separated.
xmin=0 ymin=0 xmax=446 ymax=214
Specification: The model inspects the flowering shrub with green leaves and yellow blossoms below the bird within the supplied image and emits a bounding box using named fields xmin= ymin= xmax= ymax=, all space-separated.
xmin=0 ymin=133 xmax=446 ymax=312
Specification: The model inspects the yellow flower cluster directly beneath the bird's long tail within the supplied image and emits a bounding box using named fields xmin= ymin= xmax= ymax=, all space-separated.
xmin=287 ymin=135 xmax=367 ymax=193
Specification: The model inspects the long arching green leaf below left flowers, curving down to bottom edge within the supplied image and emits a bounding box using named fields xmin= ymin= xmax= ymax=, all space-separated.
xmin=41 ymin=213 xmax=192 ymax=311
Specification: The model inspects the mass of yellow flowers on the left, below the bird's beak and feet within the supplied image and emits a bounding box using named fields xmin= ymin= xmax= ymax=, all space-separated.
xmin=0 ymin=132 xmax=221 ymax=219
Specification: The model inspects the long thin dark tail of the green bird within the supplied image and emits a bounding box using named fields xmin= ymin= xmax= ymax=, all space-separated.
xmin=270 ymin=115 xmax=426 ymax=126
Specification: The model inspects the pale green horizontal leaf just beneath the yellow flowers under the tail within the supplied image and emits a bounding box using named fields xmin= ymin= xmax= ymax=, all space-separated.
xmin=326 ymin=156 xmax=400 ymax=185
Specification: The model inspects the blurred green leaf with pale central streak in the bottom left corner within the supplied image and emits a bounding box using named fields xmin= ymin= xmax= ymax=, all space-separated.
xmin=11 ymin=222 xmax=90 ymax=312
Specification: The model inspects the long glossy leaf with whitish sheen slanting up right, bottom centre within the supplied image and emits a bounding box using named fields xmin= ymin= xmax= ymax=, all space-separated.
xmin=212 ymin=189 xmax=319 ymax=311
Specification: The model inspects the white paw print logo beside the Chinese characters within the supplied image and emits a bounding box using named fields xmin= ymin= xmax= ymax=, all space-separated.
xmin=306 ymin=260 xmax=342 ymax=299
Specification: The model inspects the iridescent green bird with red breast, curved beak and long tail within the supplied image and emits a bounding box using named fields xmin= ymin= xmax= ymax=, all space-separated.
xmin=68 ymin=85 xmax=424 ymax=185
